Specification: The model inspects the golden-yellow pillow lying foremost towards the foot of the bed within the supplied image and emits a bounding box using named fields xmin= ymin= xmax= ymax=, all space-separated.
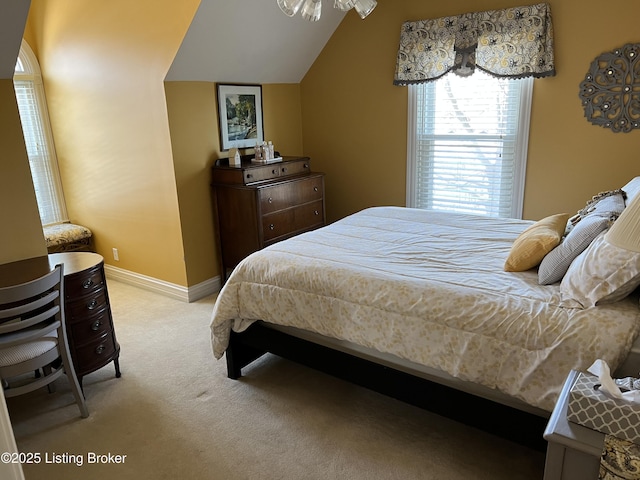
xmin=504 ymin=213 xmax=569 ymax=272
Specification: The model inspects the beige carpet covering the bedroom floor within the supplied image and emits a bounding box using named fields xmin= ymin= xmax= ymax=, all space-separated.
xmin=7 ymin=281 xmax=544 ymax=480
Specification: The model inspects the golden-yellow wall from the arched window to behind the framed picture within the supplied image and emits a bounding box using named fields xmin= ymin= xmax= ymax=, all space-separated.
xmin=25 ymin=0 xmax=303 ymax=286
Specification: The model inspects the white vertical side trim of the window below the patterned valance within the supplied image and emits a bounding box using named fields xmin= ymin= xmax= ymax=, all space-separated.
xmin=406 ymin=73 xmax=534 ymax=218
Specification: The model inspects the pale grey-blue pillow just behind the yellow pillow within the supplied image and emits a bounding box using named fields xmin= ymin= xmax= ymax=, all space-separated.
xmin=538 ymin=191 xmax=625 ymax=285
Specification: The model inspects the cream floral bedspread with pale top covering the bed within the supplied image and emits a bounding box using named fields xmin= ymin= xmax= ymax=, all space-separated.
xmin=211 ymin=207 xmax=640 ymax=411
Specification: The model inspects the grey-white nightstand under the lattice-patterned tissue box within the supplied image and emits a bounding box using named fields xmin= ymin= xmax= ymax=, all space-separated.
xmin=544 ymin=370 xmax=604 ymax=480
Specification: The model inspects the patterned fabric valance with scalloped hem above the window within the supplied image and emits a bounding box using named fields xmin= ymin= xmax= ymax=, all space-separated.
xmin=393 ymin=3 xmax=555 ymax=85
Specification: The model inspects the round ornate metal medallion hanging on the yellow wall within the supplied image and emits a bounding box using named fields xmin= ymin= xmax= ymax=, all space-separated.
xmin=580 ymin=43 xmax=640 ymax=132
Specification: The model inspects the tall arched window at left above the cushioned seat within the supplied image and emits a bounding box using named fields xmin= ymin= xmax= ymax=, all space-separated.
xmin=13 ymin=40 xmax=68 ymax=225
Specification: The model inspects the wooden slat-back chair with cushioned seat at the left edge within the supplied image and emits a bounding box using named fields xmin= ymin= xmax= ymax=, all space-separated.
xmin=0 ymin=265 xmax=89 ymax=418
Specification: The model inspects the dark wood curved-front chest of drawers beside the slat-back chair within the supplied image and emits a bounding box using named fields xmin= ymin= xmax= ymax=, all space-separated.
xmin=49 ymin=252 xmax=120 ymax=386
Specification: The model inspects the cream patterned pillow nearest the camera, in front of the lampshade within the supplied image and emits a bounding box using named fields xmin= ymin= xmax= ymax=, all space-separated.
xmin=560 ymin=232 xmax=640 ymax=308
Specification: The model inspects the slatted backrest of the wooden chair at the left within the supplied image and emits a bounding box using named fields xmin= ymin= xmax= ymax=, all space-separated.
xmin=0 ymin=265 xmax=64 ymax=335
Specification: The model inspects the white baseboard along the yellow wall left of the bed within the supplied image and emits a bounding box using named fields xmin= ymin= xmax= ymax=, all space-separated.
xmin=104 ymin=265 xmax=222 ymax=302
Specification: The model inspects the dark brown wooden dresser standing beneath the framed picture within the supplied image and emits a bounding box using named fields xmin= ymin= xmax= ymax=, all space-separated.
xmin=212 ymin=157 xmax=325 ymax=281
